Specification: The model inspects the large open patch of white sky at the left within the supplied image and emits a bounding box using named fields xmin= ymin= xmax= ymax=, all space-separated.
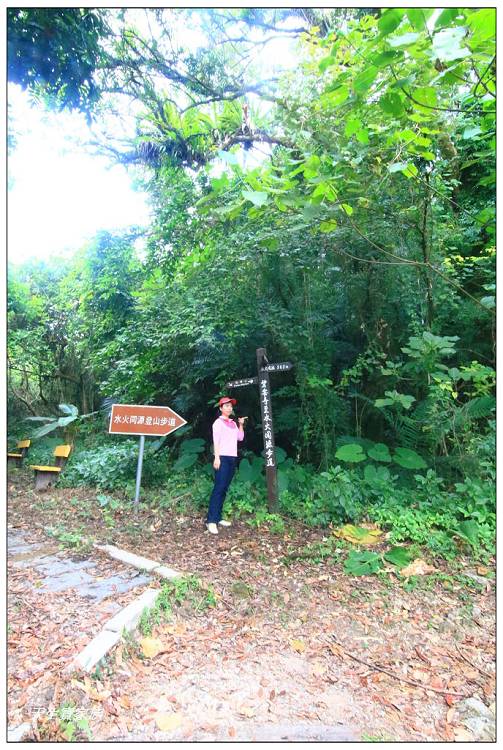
xmin=7 ymin=86 xmax=149 ymax=264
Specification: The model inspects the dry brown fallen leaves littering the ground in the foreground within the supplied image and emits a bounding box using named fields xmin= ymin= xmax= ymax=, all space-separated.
xmin=9 ymin=470 xmax=494 ymax=741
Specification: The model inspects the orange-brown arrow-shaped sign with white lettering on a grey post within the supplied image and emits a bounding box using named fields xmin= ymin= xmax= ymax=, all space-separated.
xmin=108 ymin=404 xmax=187 ymax=511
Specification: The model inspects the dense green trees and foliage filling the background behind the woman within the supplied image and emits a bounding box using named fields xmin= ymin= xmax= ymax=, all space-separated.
xmin=8 ymin=8 xmax=496 ymax=554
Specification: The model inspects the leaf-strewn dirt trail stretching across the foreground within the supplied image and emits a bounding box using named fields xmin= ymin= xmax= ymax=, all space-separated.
xmin=9 ymin=472 xmax=494 ymax=741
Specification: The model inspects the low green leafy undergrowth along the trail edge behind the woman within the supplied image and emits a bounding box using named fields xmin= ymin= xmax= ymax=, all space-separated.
xmin=20 ymin=429 xmax=496 ymax=560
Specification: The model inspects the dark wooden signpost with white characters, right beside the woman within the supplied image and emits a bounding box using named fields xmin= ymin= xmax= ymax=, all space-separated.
xmin=226 ymin=349 xmax=293 ymax=513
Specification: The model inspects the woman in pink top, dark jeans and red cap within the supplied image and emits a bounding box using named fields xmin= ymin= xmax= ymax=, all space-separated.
xmin=206 ymin=396 xmax=246 ymax=534
